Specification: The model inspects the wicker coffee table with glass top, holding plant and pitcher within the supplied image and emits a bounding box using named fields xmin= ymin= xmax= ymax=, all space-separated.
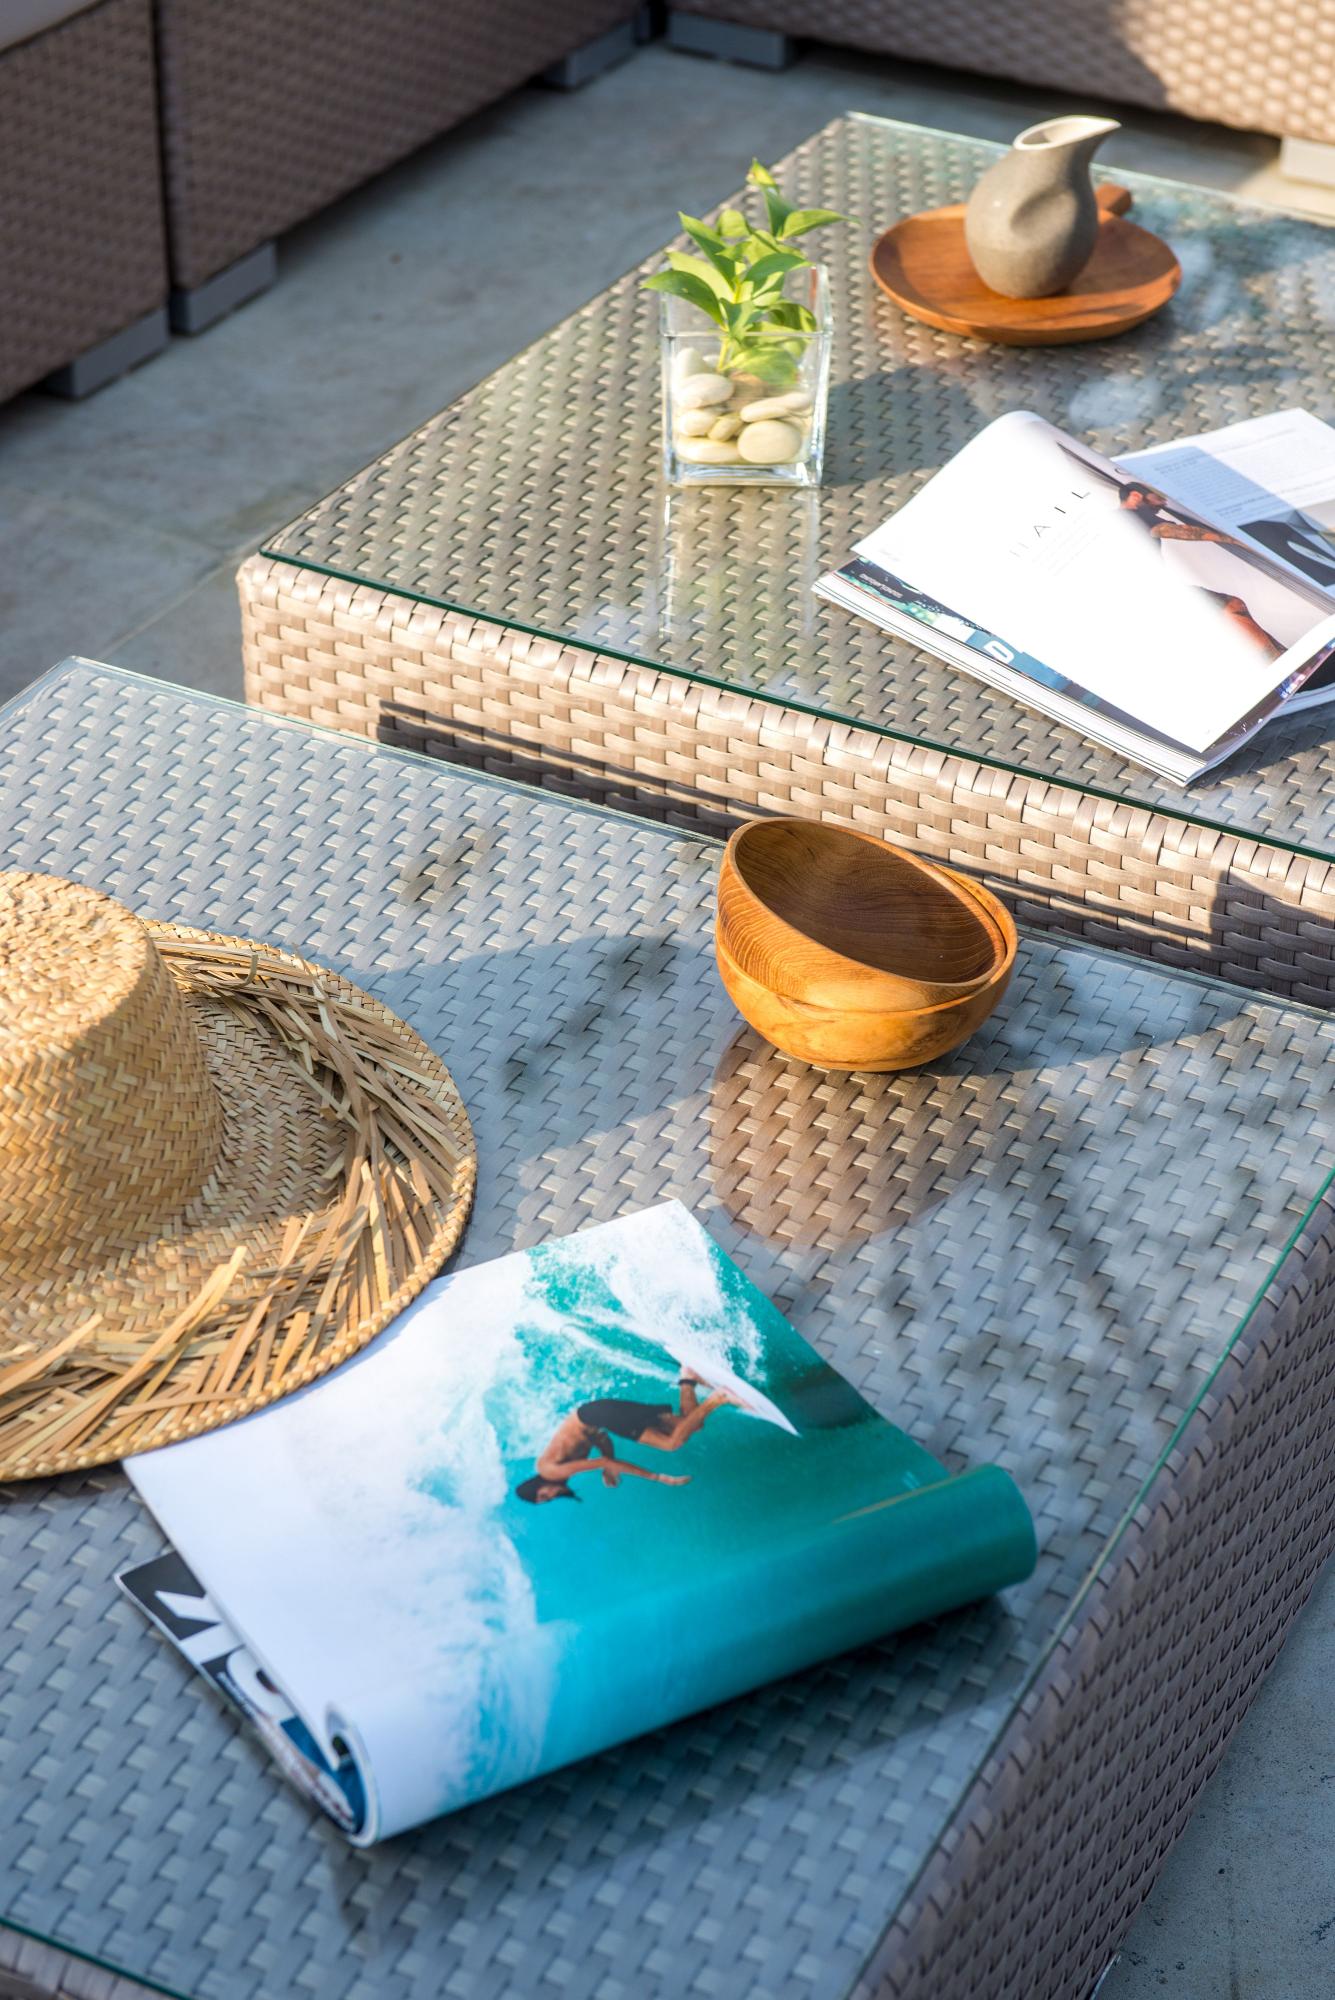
xmin=240 ymin=116 xmax=1335 ymax=1004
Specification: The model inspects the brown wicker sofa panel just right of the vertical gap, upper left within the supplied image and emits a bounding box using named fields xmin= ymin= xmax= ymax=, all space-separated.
xmin=156 ymin=0 xmax=636 ymax=286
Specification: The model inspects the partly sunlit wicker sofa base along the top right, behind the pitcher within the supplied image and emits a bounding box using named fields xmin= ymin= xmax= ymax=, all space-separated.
xmin=673 ymin=0 xmax=1335 ymax=142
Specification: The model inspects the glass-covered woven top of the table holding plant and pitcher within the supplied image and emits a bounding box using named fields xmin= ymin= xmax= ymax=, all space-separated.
xmin=266 ymin=116 xmax=1335 ymax=854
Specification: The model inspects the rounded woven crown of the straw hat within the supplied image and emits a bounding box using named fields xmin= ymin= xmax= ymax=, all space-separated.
xmin=0 ymin=872 xmax=222 ymax=1264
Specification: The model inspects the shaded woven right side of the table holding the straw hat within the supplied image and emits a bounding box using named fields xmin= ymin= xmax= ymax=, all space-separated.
xmin=855 ymin=1168 xmax=1335 ymax=2000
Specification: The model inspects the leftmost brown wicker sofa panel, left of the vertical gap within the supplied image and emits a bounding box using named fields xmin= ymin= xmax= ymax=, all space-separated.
xmin=0 ymin=0 xmax=168 ymax=402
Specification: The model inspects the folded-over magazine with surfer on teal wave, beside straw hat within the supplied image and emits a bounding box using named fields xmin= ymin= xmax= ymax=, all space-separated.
xmin=120 ymin=1202 xmax=1037 ymax=1846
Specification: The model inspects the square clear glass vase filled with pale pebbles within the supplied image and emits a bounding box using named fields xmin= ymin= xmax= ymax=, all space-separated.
xmin=662 ymin=264 xmax=831 ymax=486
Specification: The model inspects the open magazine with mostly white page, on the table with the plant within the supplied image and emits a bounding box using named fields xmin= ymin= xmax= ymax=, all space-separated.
xmin=815 ymin=410 xmax=1335 ymax=782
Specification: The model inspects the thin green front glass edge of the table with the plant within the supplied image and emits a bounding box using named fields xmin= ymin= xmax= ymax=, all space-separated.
xmin=244 ymin=568 xmax=1335 ymax=866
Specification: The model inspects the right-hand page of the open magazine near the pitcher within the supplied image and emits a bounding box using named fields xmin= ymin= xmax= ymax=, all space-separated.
xmin=1119 ymin=410 xmax=1335 ymax=594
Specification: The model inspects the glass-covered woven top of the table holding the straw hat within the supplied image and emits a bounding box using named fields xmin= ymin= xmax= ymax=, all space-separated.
xmin=0 ymin=668 xmax=1335 ymax=2000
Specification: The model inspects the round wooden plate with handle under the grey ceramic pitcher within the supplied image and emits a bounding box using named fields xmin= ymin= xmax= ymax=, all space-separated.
xmin=871 ymin=184 xmax=1181 ymax=348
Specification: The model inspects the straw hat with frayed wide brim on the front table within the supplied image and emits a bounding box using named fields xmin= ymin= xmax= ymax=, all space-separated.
xmin=0 ymin=872 xmax=476 ymax=1480
